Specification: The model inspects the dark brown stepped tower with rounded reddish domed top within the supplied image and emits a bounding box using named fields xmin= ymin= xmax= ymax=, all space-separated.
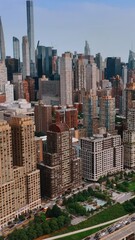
xmin=38 ymin=123 xmax=82 ymax=198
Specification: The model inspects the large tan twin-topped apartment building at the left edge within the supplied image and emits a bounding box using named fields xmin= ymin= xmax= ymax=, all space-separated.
xmin=0 ymin=116 xmax=41 ymax=230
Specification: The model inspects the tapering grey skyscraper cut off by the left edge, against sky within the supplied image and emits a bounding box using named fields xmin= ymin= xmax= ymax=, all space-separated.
xmin=0 ymin=17 xmax=6 ymax=61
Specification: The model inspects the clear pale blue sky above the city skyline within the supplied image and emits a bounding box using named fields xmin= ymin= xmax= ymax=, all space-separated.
xmin=0 ymin=0 xmax=135 ymax=61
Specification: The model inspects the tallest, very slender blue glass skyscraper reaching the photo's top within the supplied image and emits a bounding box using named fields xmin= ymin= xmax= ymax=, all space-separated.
xmin=26 ymin=0 xmax=35 ymax=76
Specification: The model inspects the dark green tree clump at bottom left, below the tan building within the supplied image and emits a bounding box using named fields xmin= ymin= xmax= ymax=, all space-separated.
xmin=8 ymin=205 xmax=71 ymax=240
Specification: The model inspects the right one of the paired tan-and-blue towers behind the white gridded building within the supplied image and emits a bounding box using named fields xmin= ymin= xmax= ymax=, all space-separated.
xmin=99 ymin=89 xmax=115 ymax=133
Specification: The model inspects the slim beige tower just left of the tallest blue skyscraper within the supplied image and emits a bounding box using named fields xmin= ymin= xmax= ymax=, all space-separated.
xmin=22 ymin=36 xmax=30 ymax=78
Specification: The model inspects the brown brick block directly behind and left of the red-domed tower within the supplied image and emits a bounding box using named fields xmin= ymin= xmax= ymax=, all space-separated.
xmin=34 ymin=101 xmax=52 ymax=134
